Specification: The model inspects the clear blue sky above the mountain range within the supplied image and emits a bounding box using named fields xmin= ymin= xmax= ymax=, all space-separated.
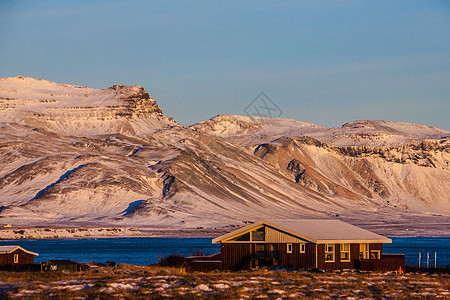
xmin=0 ymin=0 xmax=450 ymax=129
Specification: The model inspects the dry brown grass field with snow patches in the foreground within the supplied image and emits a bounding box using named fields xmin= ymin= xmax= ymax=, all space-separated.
xmin=0 ymin=264 xmax=450 ymax=299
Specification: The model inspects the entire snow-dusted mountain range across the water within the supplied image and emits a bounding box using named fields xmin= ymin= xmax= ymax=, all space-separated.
xmin=0 ymin=77 xmax=450 ymax=232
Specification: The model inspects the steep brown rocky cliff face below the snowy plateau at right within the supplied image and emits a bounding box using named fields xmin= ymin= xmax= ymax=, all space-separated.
xmin=251 ymin=138 xmax=450 ymax=213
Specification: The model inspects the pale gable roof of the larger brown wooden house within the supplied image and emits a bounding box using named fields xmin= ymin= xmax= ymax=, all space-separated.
xmin=212 ymin=219 xmax=392 ymax=244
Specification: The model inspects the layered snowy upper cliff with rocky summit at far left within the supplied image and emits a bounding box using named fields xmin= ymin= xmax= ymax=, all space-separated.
xmin=0 ymin=76 xmax=178 ymax=135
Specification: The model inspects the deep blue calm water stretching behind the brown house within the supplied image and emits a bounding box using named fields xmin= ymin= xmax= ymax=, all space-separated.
xmin=0 ymin=237 xmax=450 ymax=267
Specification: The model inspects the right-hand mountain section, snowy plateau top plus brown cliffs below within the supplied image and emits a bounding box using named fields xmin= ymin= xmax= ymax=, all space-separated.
xmin=193 ymin=116 xmax=450 ymax=225
